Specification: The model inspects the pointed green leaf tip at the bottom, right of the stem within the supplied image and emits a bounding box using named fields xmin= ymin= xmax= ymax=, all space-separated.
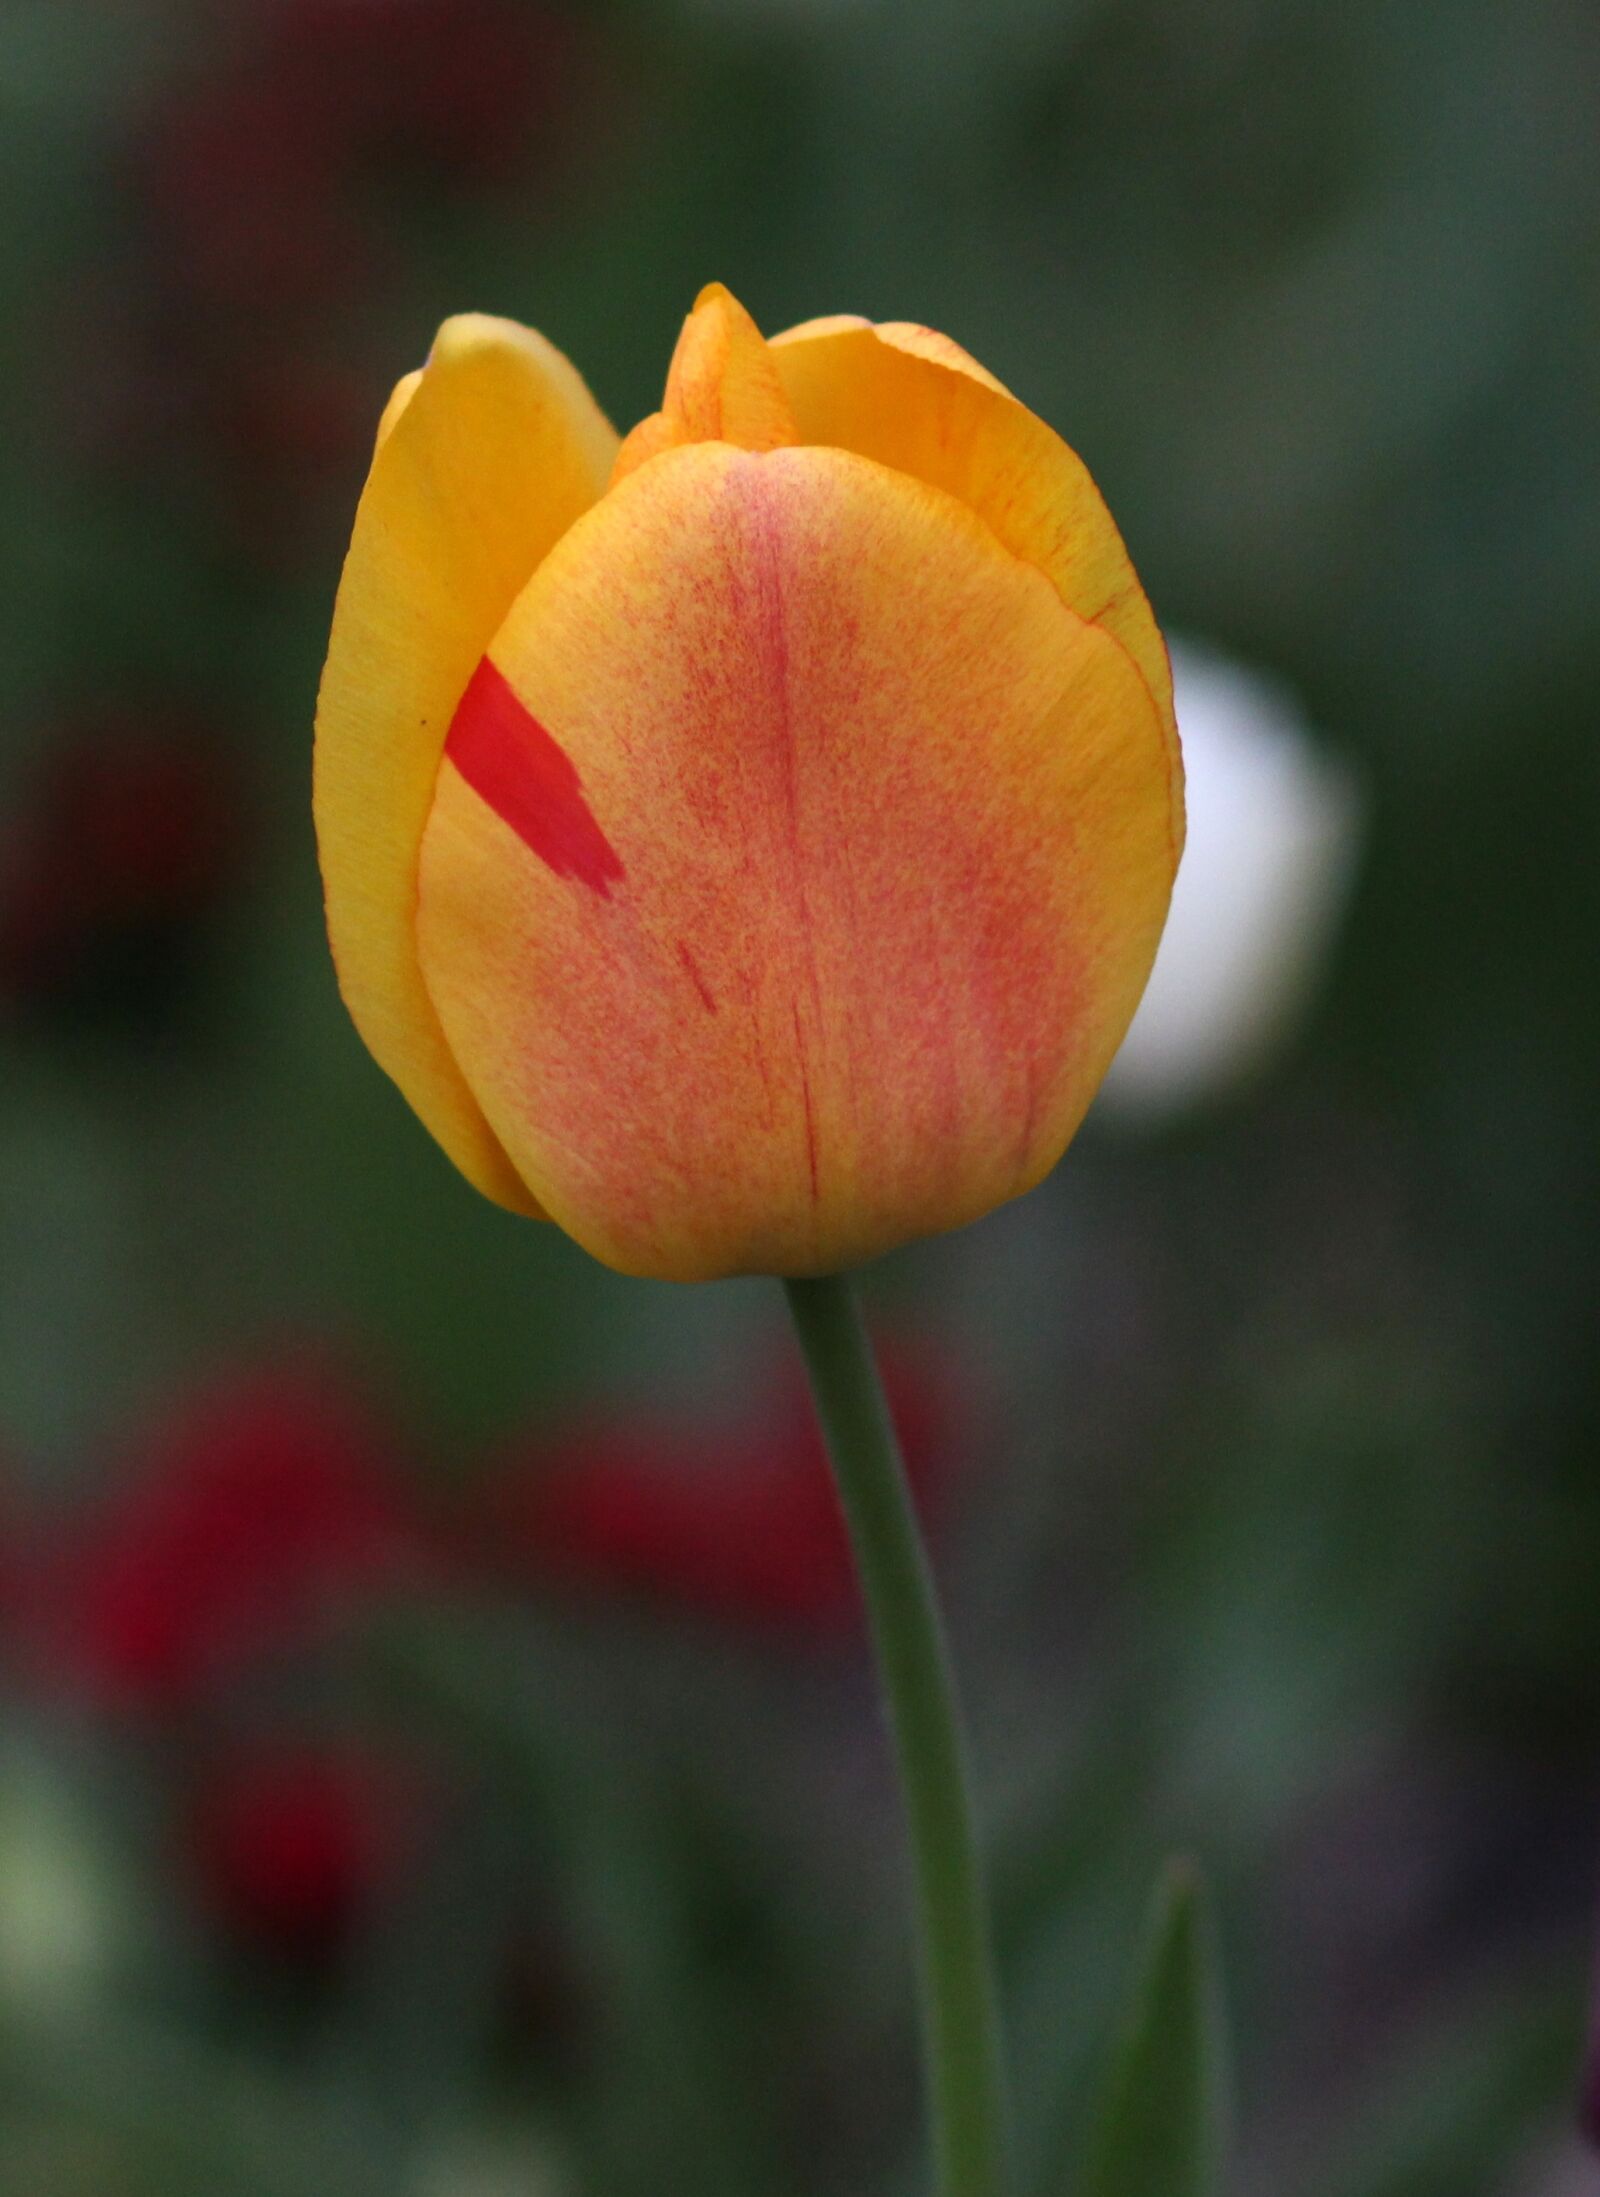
xmin=1079 ymin=1861 xmax=1226 ymax=2197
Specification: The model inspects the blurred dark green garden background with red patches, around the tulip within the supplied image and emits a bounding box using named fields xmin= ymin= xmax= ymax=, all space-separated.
xmin=0 ymin=0 xmax=1600 ymax=2197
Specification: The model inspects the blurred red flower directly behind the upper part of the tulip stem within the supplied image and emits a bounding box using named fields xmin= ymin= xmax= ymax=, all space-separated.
xmin=479 ymin=1349 xmax=956 ymax=1632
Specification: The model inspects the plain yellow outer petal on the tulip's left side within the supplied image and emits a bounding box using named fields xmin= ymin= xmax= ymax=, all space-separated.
xmin=314 ymin=314 xmax=618 ymax=1211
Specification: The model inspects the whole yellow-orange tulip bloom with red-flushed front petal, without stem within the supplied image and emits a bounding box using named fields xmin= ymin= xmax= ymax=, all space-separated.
xmin=316 ymin=286 xmax=1182 ymax=1281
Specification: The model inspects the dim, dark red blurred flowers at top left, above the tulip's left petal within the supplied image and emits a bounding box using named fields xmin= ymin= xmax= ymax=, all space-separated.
xmin=119 ymin=0 xmax=598 ymax=571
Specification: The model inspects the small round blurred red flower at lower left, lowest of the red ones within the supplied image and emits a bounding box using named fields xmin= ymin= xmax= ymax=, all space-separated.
xmin=182 ymin=1742 xmax=426 ymax=1966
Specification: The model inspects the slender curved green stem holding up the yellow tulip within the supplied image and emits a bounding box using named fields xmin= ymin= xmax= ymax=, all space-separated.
xmin=785 ymin=1274 xmax=1004 ymax=2197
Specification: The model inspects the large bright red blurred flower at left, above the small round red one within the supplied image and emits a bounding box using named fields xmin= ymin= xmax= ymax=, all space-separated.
xmin=48 ymin=1367 xmax=435 ymax=1707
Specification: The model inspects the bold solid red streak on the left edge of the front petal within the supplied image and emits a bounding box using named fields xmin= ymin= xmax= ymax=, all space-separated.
xmin=444 ymin=657 xmax=624 ymax=901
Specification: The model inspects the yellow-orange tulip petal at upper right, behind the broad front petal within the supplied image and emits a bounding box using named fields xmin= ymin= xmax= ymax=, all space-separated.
xmin=769 ymin=319 xmax=1180 ymax=813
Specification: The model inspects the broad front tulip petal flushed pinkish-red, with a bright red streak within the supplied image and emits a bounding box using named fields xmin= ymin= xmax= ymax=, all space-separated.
xmin=418 ymin=442 xmax=1174 ymax=1279
